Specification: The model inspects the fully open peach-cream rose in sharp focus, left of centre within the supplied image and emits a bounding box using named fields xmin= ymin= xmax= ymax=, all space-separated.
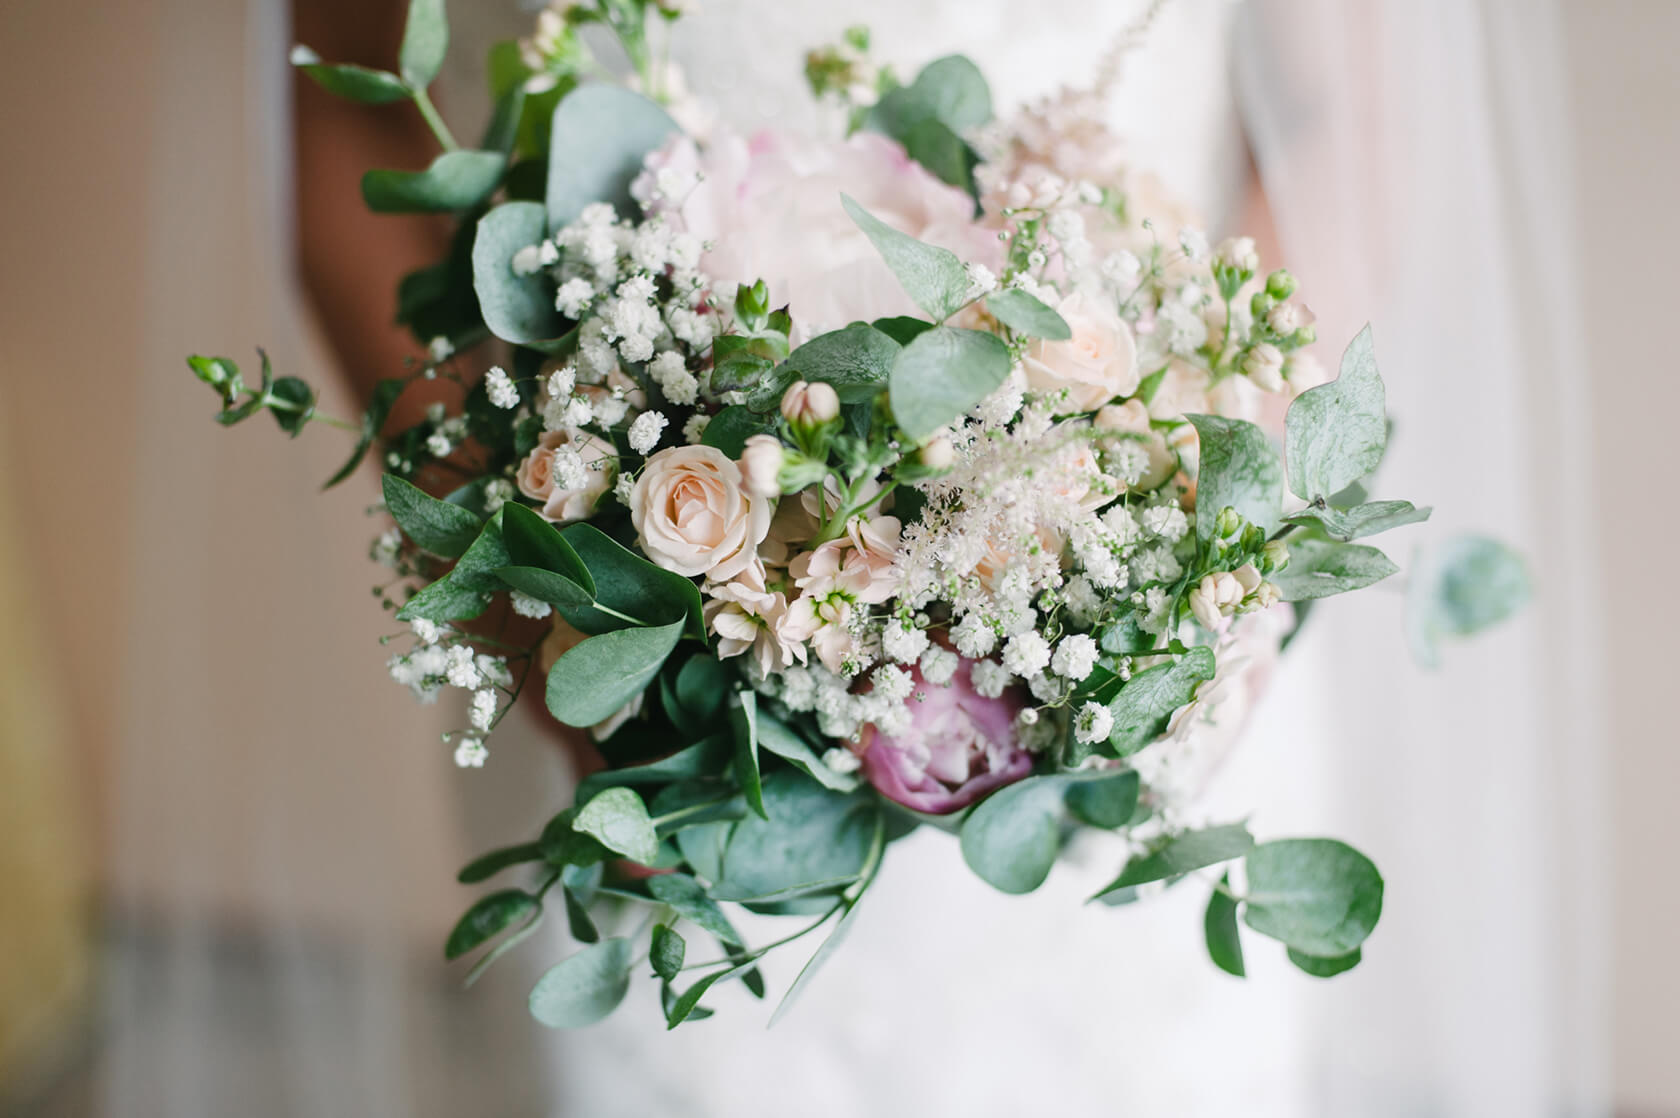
xmin=630 ymin=446 xmax=774 ymax=582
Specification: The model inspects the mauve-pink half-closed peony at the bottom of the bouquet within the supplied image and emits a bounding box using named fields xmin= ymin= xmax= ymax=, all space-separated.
xmin=852 ymin=659 xmax=1033 ymax=815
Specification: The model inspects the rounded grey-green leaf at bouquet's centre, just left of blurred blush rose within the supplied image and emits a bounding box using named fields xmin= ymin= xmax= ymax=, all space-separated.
xmin=890 ymin=326 xmax=1010 ymax=442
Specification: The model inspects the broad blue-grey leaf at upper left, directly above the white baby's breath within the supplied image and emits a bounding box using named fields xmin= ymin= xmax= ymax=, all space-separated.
xmin=548 ymin=82 xmax=682 ymax=230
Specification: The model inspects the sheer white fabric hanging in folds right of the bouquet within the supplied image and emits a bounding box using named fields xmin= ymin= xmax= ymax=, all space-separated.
xmin=1236 ymin=0 xmax=1609 ymax=1116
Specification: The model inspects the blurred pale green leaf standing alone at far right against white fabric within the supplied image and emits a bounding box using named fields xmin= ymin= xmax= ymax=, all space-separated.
xmin=1411 ymin=536 xmax=1532 ymax=667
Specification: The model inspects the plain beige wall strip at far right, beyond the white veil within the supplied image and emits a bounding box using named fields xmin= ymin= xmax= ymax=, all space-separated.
xmin=1559 ymin=0 xmax=1680 ymax=1115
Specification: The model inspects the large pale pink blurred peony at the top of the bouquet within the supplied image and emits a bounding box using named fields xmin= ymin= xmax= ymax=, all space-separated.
xmin=632 ymin=131 xmax=1000 ymax=336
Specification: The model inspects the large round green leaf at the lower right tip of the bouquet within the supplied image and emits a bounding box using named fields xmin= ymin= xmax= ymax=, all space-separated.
xmin=1243 ymin=839 xmax=1383 ymax=958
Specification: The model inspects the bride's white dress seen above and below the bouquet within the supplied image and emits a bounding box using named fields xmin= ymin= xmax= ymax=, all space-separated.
xmin=440 ymin=0 xmax=1330 ymax=1118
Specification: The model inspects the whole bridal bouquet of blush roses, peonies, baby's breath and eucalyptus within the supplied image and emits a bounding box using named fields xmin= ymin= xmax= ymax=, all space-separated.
xmin=190 ymin=0 xmax=1522 ymax=1027
